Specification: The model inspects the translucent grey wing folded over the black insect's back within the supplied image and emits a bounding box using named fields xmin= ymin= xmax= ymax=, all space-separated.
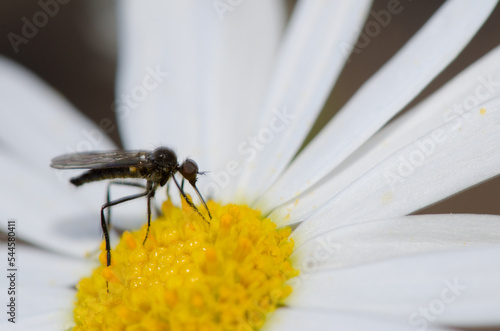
xmin=50 ymin=151 xmax=150 ymax=169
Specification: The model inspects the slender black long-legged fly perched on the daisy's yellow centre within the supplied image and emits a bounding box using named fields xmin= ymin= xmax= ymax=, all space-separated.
xmin=50 ymin=147 xmax=212 ymax=266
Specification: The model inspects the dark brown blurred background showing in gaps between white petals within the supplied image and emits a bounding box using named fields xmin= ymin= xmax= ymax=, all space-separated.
xmin=0 ymin=0 xmax=500 ymax=214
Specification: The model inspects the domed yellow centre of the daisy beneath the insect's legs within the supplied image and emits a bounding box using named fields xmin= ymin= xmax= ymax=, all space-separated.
xmin=74 ymin=201 xmax=298 ymax=331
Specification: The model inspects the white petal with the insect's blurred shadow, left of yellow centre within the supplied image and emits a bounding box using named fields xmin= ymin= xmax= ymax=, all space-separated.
xmin=0 ymin=154 xmax=104 ymax=256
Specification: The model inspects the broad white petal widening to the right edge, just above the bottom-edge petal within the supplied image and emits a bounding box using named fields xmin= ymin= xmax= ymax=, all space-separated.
xmin=287 ymin=247 xmax=500 ymax=327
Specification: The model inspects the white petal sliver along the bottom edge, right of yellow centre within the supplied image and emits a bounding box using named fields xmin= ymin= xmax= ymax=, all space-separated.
xmin=262 ymin=308 xmax=444 ymax=331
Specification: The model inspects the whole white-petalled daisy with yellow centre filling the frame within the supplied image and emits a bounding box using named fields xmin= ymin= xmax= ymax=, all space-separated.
xmin=0 ymin=0 xmax=500 ymax=330
